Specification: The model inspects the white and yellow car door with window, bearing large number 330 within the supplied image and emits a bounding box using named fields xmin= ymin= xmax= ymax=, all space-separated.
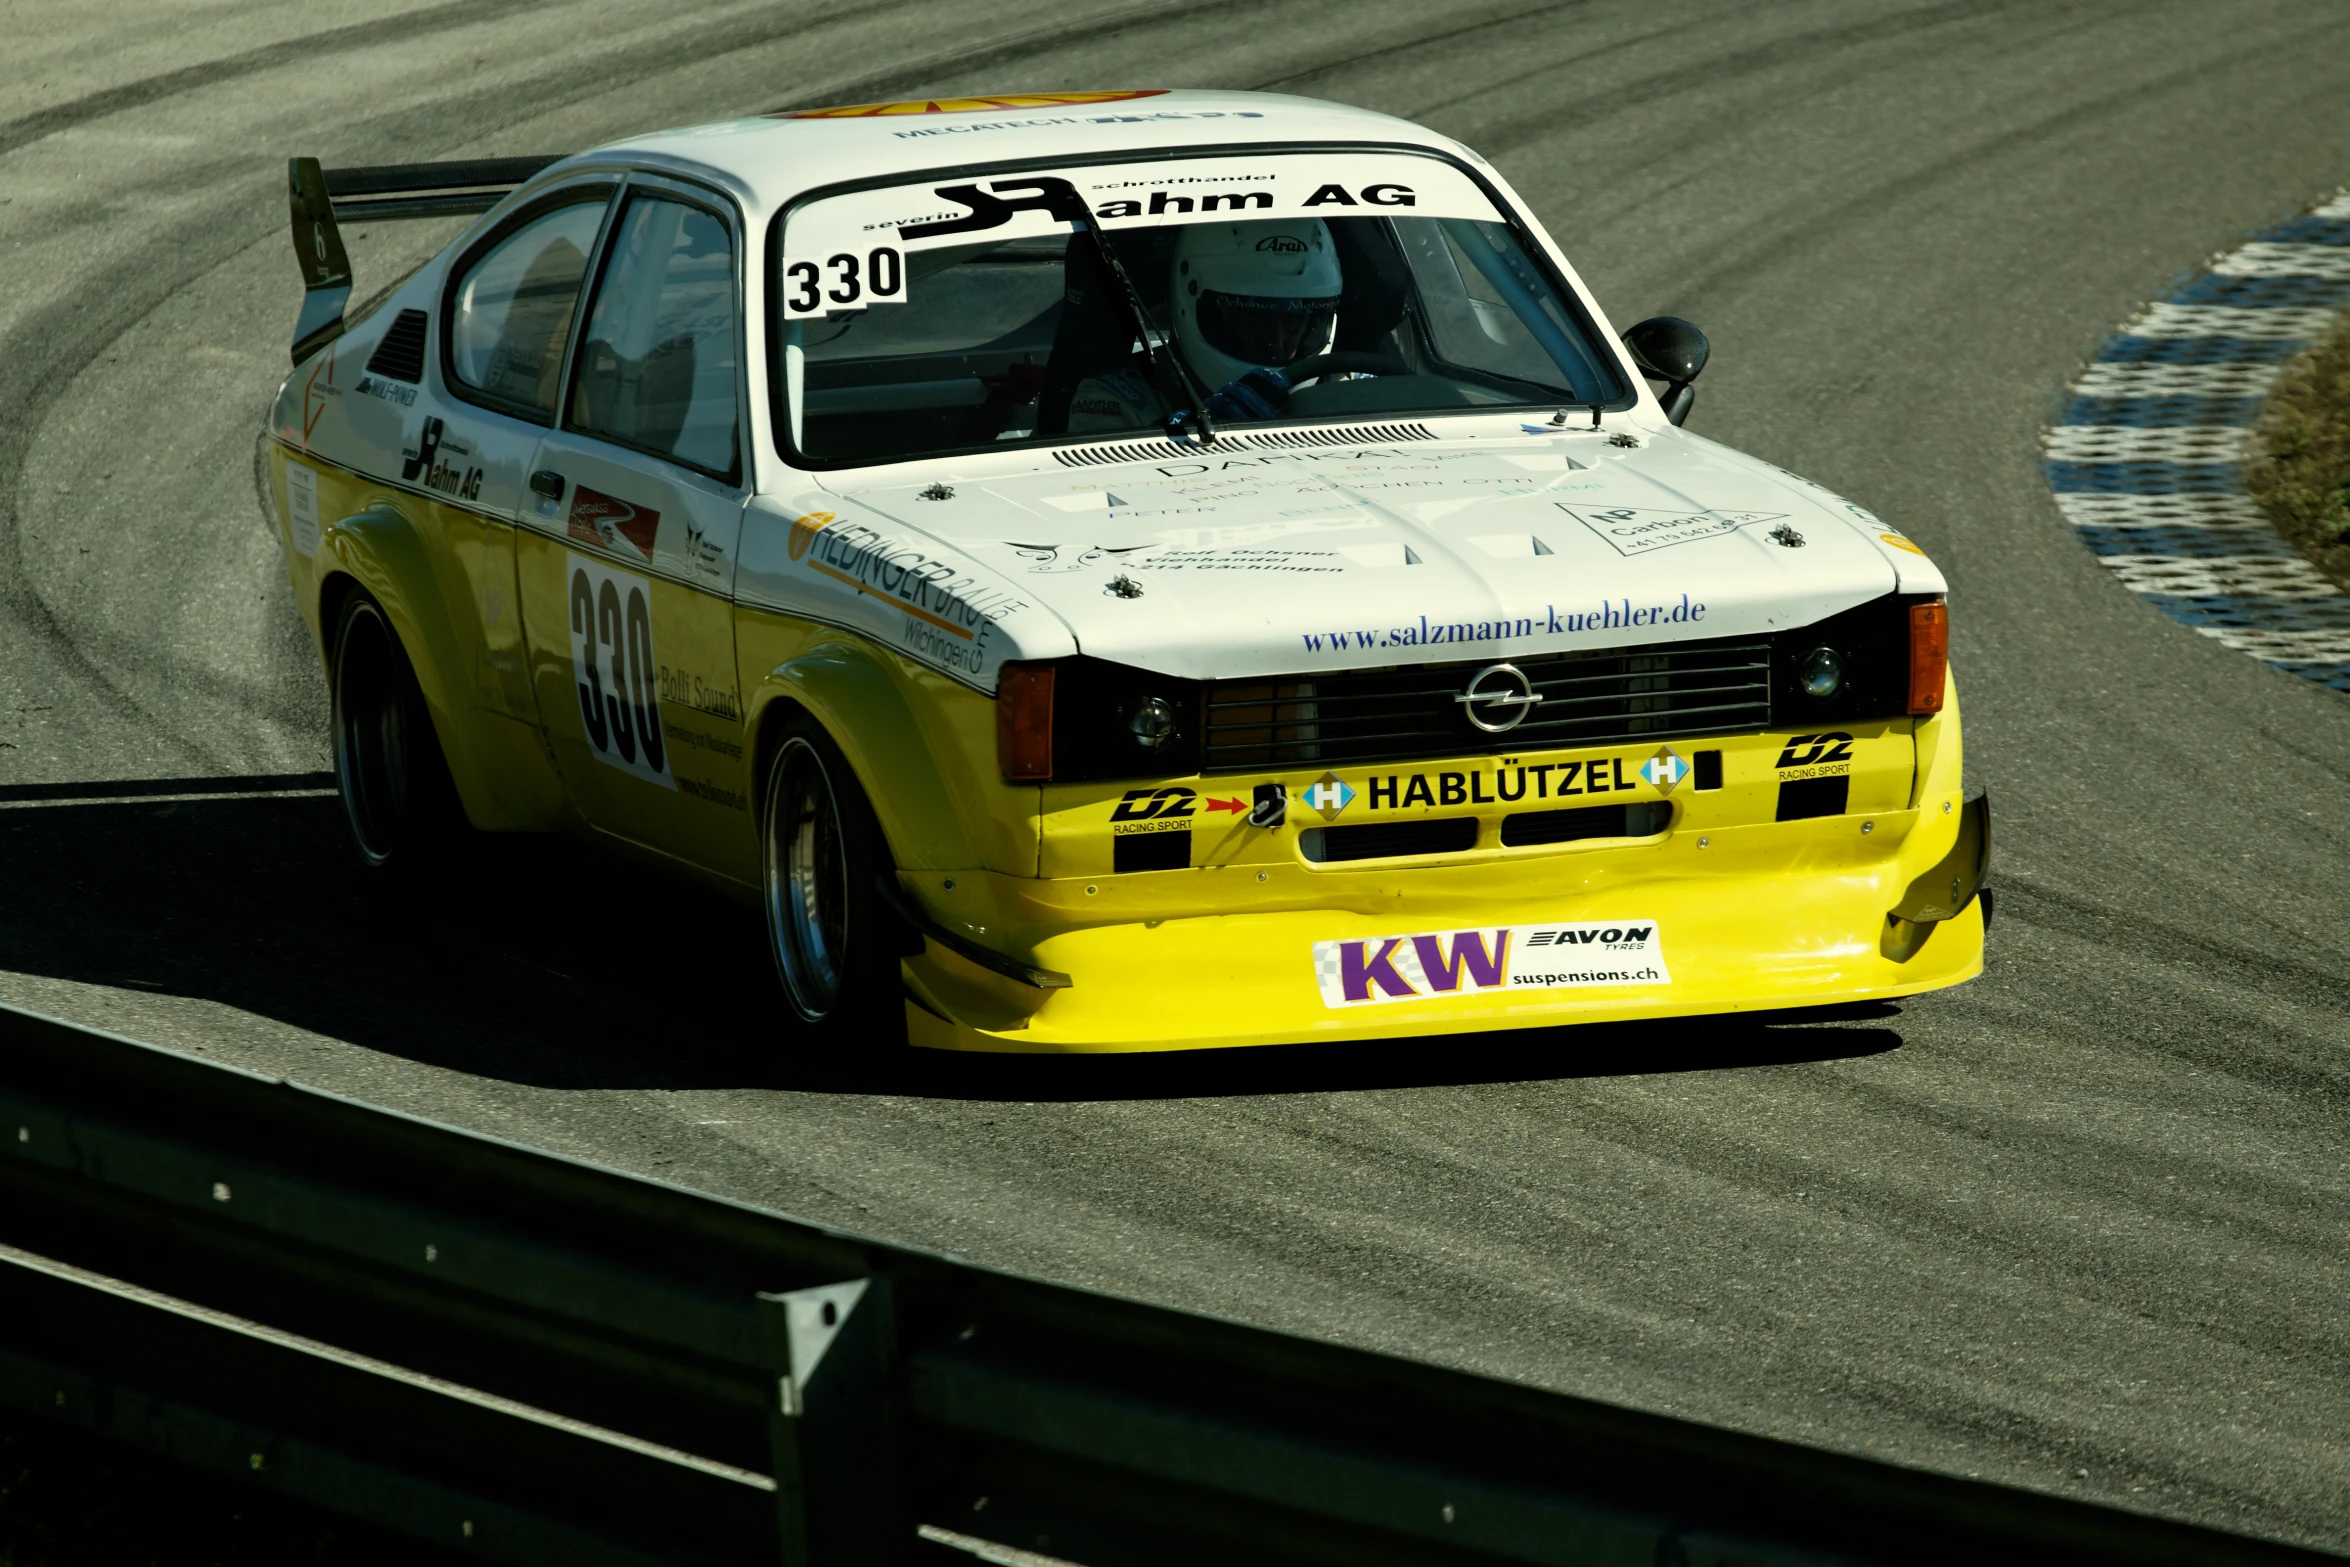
xmin=519 ymin=176 xmax=754 ymax=881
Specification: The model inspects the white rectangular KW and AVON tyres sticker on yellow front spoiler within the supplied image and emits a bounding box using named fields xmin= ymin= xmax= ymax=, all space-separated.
xmin=1314 ymin=919 xmax=1673 ymax=1008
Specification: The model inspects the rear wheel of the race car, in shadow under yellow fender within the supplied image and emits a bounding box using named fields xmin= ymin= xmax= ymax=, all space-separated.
xmin=329 ymin=590 xmax=465 ymax=886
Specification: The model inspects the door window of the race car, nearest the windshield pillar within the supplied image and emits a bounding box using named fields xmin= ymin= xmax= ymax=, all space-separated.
xmin=569 ymin=195 xmax=736 ymax=477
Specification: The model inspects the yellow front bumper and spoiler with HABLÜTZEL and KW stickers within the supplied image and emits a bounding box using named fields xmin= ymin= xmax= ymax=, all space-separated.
xmin=900 ymin=676 xmax=1983 ymax=1050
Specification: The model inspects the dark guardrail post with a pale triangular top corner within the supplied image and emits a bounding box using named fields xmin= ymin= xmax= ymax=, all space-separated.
xmin=759 ymin=1278 xmax=914 ymax=1567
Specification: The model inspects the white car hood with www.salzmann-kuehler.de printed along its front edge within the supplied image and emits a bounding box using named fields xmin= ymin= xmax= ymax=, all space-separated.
xmin=808 ymin=430 xmax=1941 ymax=684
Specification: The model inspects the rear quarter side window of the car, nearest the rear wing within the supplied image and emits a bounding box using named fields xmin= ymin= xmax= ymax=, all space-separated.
xmin=449 ymin=197 xmax=604 ymax=416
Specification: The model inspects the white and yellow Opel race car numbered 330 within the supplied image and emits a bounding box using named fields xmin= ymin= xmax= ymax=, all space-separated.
xmin=270 ymin=92 xmax=1988 ymax=1050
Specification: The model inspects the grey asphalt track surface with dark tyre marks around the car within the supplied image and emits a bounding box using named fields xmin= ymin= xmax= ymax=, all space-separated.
xmin=0 ymin=0 xmax=2350 ymax=1551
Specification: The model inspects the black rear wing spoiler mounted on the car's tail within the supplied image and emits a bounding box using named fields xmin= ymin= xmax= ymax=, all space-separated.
xmin=287 ymin=157 xmax=562 ymax=364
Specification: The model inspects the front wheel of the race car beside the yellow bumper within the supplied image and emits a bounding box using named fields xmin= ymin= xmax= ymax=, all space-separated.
xmin=759 ymin=719 xmax=909 ymax=1050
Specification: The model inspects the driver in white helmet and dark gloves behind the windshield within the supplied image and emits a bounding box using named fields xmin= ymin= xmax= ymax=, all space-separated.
xmin=1069 ymin=218 xmax=1342 ymax=430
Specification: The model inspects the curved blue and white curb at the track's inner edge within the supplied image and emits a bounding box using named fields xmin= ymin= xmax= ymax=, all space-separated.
xmin=2042 ymin=195 xmax=2350 ymax=691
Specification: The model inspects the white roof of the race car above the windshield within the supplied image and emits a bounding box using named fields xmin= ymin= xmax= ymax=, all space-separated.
xmin=556 ymin=89 xmax=1485 ymax=221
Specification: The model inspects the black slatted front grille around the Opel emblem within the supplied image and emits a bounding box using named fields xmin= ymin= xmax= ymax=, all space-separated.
xmin=1206 ymin=641 xmax=1772 ymax=773
